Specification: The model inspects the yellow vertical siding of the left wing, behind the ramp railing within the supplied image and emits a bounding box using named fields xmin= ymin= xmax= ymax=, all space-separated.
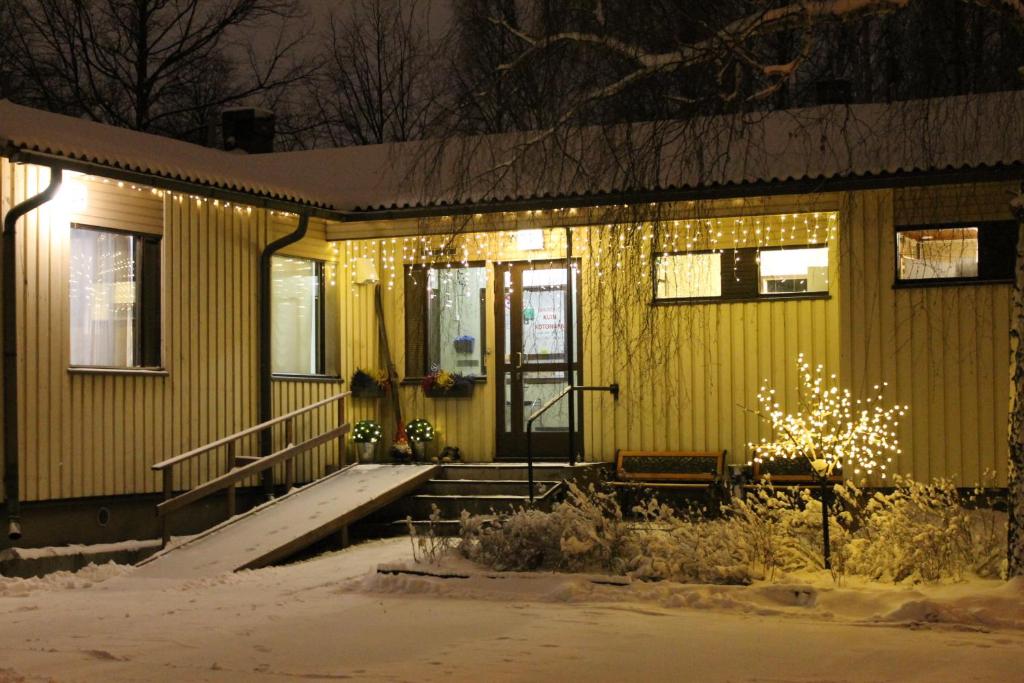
xmin=2 ymin=160 xmax=341 ymax=501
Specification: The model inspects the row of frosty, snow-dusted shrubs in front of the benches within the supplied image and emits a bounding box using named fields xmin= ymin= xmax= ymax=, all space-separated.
xmin=459 ymin=477 xmax=1007 ymax=584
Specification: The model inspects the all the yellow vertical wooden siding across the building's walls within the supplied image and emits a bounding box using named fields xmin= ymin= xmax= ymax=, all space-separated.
xmin=0 ymin=160 xmax=1011 ymax=501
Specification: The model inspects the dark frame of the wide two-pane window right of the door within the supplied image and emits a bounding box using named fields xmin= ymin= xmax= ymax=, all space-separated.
xmin=650 ymin=242 xmax=831 ymax=306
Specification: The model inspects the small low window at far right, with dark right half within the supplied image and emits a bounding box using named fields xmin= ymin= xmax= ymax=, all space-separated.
xmin=896 ymin=221 xmax=1017 ymax=286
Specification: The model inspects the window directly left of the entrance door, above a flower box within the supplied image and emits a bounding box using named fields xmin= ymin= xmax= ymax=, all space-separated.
xmin=406 ymin=265 xmax=487 ymax=377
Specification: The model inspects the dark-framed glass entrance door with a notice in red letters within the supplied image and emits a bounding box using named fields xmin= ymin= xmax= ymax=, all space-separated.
xmin=495 ymin=261 xmax=581 ymax=460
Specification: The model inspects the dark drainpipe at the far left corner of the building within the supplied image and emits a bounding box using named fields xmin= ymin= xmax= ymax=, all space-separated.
xmin=0 ymin=167 xmax=63 ymax=541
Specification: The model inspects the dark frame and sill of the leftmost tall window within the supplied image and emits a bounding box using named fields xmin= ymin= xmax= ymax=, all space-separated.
xmin=67 ymin=221 xmax=161 ymax=375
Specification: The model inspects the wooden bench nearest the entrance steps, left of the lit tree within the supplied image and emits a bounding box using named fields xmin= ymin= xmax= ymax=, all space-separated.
xmin=608 ymin=451 xmax=725 ymax=501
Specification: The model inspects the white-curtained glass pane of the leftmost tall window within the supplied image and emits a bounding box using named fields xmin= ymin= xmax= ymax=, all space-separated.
xmin=69 ymin=227 xmax=137 ymax=368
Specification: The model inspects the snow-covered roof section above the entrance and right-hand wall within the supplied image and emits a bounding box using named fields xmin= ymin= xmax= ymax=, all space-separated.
xmin=258 ymin=91 xmax=1024 ymax=212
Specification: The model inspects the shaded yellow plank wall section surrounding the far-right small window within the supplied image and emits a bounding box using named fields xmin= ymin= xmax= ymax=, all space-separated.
xmin=841 ymin=184 xmax=1012 ymax=485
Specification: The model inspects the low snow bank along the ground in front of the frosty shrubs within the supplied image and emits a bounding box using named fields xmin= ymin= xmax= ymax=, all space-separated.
xmin=358 ymin=553 xmax=1024 ymax=631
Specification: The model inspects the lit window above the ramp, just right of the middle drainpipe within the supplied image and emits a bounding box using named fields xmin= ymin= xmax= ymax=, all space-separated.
xmin=270 ymin=256 xmax=340 ymax=377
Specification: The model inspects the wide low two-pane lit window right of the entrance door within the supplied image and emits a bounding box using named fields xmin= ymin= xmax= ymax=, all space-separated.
xmin=654 ymin=245 xmax=828 ymax=303
